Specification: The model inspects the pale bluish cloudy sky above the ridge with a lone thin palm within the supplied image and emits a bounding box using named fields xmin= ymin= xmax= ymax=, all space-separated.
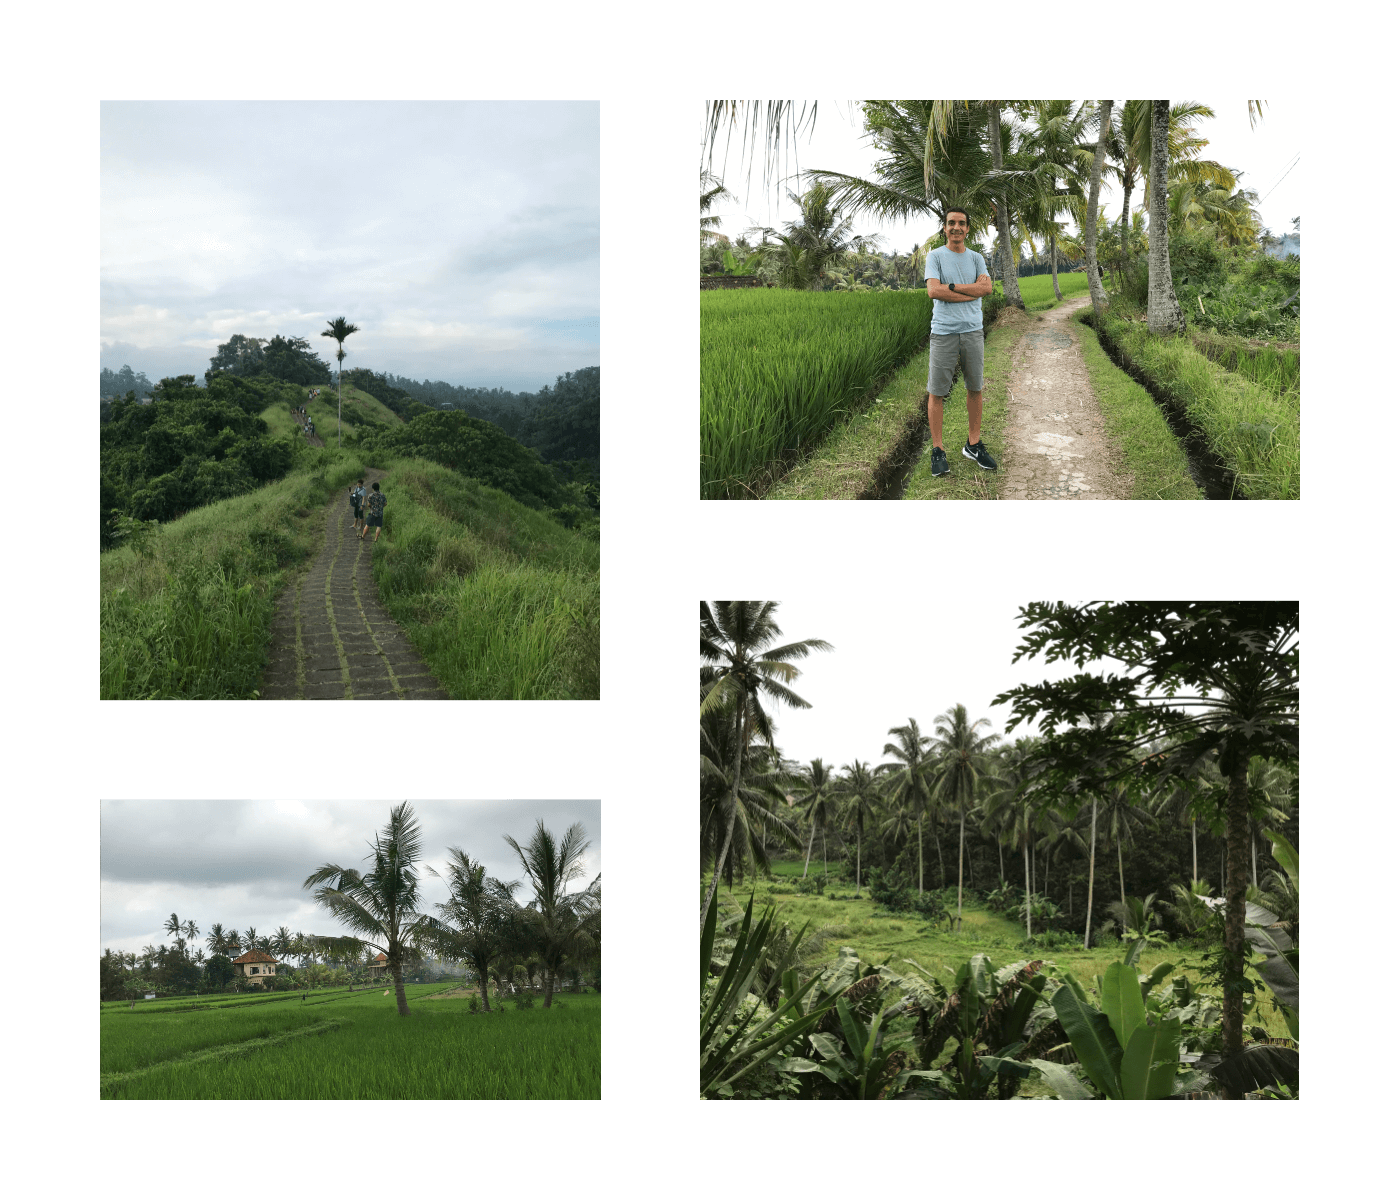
xmin=99 ymin=101 xmax=601 ymax=393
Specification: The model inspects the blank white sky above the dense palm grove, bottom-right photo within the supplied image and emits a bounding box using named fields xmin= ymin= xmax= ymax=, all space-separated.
xmin=700 ymin=600 xmax=1280 ymax=773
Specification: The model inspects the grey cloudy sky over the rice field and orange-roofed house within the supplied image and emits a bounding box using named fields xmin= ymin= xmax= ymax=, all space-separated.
xmin=98 ymin=800 xmax=603 ymax=959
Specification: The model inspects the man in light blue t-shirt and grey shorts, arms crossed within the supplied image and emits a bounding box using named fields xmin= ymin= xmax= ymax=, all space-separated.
xmin=925 ymin=208 xmax=995 ymax=476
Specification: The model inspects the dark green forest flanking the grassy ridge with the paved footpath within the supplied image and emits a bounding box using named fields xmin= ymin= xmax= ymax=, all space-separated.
xmin=99 ymin=334 xmax=601 ymax=551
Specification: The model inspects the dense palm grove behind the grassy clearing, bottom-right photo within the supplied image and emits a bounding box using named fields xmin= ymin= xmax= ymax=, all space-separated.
xmin=700 ymin=601 xmax=1300 ymax=936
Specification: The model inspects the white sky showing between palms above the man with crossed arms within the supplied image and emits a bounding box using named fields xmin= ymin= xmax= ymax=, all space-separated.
xmin=699 ymin=99 xmax=1302 ymax=268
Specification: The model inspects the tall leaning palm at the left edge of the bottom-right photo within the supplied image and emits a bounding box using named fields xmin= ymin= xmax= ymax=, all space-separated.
xmin=699 ymin=600 xmax=833 ymax=933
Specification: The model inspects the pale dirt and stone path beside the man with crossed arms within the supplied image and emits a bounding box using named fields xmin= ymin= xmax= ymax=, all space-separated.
xmin=1000 ymin=297 xmax=1132 ymax=499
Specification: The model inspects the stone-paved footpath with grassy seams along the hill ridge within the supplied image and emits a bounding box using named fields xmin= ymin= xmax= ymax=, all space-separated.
xmin=261 ymin=470 xmax=452 ymax=701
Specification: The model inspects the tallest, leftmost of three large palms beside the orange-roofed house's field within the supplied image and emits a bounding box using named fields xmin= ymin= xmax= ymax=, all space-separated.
xmin=302 ymin=800 xmax=447 ymax=1017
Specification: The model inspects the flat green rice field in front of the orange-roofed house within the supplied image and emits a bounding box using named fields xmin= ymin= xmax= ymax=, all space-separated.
xmin=98 ymin=983 xmax=603 ymax=1099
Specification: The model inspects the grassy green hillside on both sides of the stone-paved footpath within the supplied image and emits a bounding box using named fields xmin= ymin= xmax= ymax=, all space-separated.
xmin=99 ymin=447 xmax=601 ymax=701
